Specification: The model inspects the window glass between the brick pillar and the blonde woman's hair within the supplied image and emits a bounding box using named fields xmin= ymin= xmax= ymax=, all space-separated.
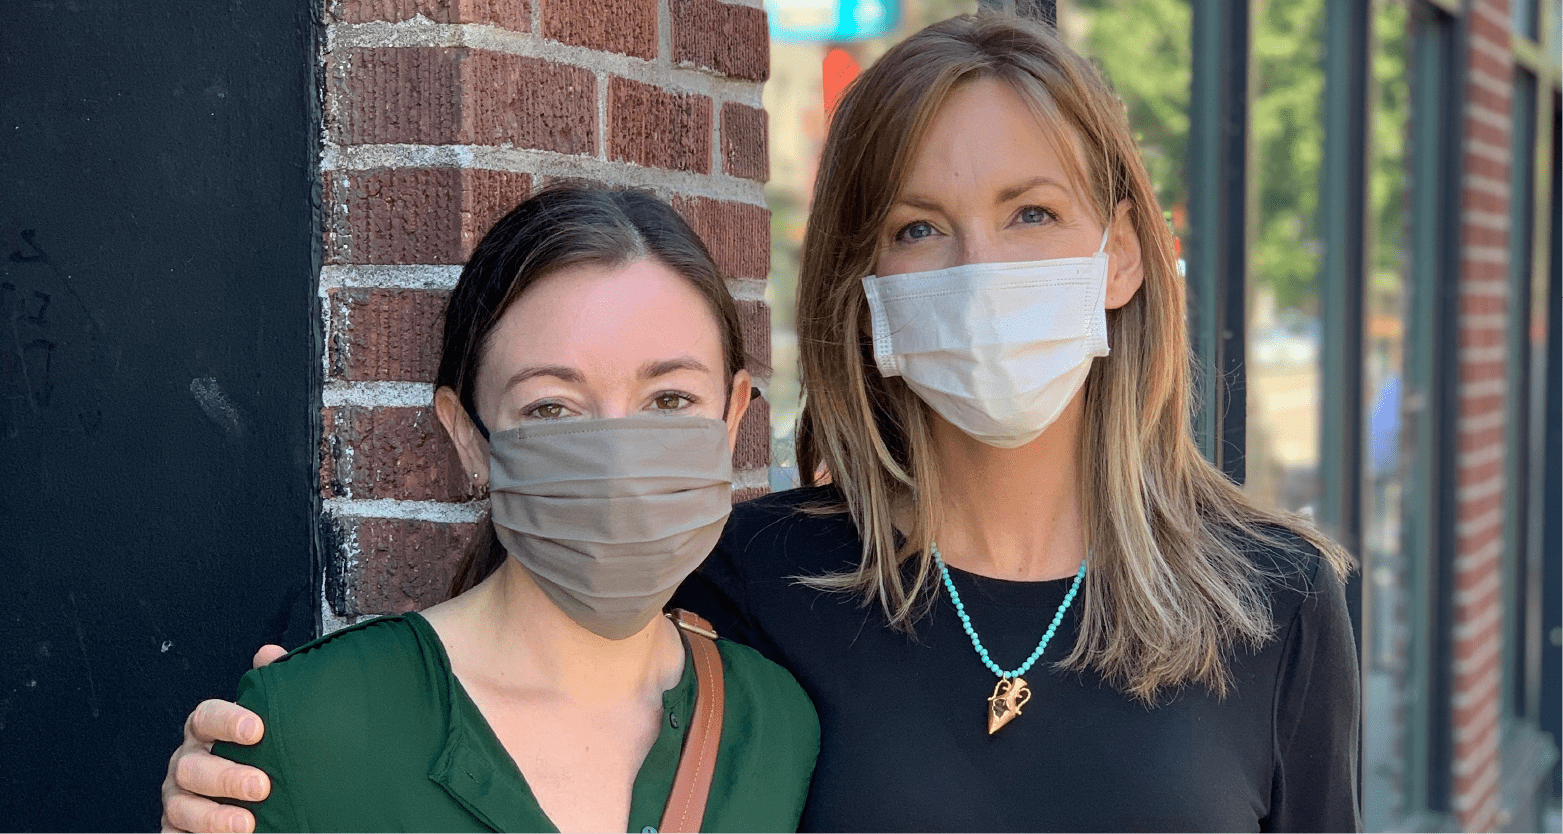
xmin=764 ymin=0 xmax=978 ymax=489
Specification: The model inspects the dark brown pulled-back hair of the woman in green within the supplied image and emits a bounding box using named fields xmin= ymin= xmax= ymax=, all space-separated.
xmin=435 ymin=184 xmax=746 ymax=597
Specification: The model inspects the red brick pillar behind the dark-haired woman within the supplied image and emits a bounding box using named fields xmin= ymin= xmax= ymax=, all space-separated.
xmin=320 ymin=0 xmax=771 ymax=631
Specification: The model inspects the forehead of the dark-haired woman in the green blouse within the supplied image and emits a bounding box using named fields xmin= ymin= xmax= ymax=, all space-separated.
xmin=483 ymin=261 xmax=722 ymax=375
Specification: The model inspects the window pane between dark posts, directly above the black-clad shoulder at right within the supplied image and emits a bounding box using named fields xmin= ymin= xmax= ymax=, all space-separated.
xmin=1246 ymin=0 xmax=1325 ymax=514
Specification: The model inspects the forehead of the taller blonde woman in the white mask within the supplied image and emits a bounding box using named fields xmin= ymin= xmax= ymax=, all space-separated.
xmin=902 ymin=78 xmax=1085 ymax=203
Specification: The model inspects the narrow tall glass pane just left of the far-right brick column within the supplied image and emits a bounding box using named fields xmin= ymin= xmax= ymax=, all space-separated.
xmin=1361 ymin=2 xmax=1411 ymax=831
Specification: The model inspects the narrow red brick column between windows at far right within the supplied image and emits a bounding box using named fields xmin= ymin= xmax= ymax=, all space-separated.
xmin=1452 ymin=0 xmax=1515 ymax=831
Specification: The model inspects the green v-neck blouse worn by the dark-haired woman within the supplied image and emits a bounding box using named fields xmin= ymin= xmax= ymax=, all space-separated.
xmin=213 ymin=614 xmax=819 ymax=834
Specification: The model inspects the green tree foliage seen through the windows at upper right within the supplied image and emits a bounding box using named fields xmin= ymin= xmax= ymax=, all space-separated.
xmin=1064 ymin=0 xmax=1407 ymax=314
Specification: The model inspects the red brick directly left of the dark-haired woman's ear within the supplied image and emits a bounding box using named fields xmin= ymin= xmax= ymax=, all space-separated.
xmin=320 ymin=406 xmax=462 ymax=501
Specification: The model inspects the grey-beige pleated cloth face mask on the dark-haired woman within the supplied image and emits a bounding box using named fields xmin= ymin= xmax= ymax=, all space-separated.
xmin=489 ymin=414 xmax=733 ymax=640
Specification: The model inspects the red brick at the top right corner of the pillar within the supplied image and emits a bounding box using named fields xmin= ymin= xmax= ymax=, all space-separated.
xmin=667 ymin=0 xmax=771 ymax=81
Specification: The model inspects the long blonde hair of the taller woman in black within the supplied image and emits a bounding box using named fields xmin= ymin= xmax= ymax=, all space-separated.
xmin=797 ymin=14 xmax=1350 ymax=703
